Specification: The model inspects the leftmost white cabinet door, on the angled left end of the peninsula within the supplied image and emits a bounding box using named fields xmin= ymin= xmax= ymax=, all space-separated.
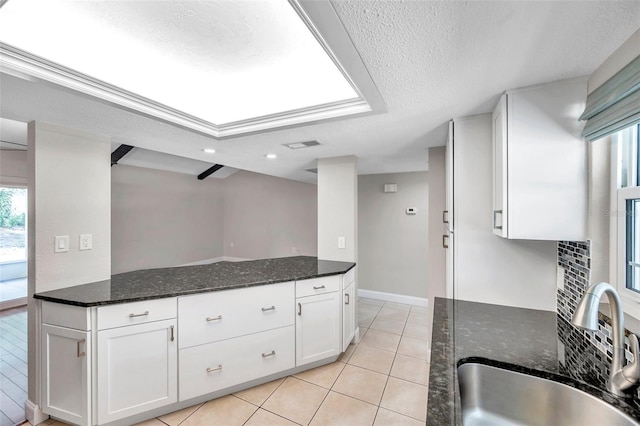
xmin=41 ymin=324 xmax=91 ymax=426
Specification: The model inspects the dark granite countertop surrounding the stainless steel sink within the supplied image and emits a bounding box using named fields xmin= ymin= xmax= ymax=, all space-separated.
xmin=427 ymin=298 xmax=640 ymax=426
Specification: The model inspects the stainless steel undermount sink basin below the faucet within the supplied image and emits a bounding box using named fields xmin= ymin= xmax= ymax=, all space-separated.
xmin=458 ymin=362 xmax=640 ymax=426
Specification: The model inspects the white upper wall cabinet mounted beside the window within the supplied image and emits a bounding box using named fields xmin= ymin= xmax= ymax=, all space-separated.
xmin=492 ymin=78 xmax=587 ymax=241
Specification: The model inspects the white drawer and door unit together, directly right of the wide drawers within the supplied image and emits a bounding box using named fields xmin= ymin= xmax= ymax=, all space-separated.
xmin=296 ymin=276 xmax=342 ymax=366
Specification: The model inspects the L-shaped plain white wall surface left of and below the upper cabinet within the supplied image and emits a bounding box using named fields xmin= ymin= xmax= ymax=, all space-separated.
xmin=453 ymin=114 xmax=557 ymax=311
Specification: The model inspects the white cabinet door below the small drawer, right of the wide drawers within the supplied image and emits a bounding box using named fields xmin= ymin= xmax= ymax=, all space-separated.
xmin=296 ymin=292 xmax=342 ymax=366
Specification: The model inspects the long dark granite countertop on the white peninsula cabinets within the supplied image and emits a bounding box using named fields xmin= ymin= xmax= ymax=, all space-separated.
xmin=33 ymin=256 xmax=355 ymax=307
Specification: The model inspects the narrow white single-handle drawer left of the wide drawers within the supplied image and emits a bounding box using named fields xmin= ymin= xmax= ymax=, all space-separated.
xmin=98 ymin=297 xmax=177 ymax=330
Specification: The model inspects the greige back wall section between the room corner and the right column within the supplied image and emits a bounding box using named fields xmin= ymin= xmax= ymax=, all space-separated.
xmin=223 ymin=171 xmax=318 ymax=259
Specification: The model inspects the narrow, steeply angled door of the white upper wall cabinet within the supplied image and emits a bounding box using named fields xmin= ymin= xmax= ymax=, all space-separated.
xmin=492 ymin=95 xmax=509 ymax=237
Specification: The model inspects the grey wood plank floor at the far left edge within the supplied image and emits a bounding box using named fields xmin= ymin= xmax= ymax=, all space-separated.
xmin=0 ymin=306 xmax=27 ymax=426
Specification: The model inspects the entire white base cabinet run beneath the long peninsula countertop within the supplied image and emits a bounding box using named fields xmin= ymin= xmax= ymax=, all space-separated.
xmin=40 ymin=273 xmax=356 ymax=426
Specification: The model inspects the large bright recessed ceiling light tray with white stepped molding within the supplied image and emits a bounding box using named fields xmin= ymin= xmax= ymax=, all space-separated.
xmin=0 ymin=0 xmax=384 ymax=138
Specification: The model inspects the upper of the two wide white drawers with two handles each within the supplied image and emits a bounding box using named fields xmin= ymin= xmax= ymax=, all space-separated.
xmin=178 ymin=282 xmax=295 ymax=348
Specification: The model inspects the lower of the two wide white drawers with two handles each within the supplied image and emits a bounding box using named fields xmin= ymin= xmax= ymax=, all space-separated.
xmin=178 ymin=325 xmax=295 ymax=401
